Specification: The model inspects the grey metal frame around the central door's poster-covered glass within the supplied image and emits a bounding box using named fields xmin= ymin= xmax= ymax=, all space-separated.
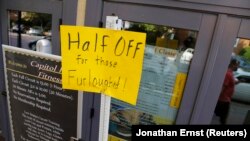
xmin=86 ymin=0 xmax=217 ymax=139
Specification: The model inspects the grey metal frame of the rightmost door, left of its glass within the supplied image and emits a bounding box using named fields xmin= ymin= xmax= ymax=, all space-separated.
xmin=190 ymin=17 xmax=250 ymax=124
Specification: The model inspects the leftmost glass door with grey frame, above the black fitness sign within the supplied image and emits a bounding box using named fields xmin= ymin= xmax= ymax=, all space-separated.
xmin=1 ymin=0 xmax=62 ymax=55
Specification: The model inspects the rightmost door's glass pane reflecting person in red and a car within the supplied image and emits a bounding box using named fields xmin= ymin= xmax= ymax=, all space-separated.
xmin=211 ymin=38 xmax=250 ymax=124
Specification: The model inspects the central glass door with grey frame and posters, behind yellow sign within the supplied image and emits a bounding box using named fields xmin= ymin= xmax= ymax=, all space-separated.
xmin=102 ymin=2 xmax=216 ymax=141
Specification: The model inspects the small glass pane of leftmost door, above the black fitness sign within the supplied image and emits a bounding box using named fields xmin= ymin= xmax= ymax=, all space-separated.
xmin=8 ymin=10 xmax=52 ymax=50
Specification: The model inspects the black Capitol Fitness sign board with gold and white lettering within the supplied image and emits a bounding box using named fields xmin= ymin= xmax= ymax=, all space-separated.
xmin=3 ymin=45 xmax=82 ymax=141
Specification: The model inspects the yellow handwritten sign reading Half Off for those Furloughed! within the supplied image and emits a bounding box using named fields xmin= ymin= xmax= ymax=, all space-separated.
xmin=60 ymin=25 xmax=146 ymax=105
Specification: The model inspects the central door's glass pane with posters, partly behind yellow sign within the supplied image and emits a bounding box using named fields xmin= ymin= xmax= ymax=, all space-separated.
xmin=109 ymin=21 xmax=198 ymax=141
